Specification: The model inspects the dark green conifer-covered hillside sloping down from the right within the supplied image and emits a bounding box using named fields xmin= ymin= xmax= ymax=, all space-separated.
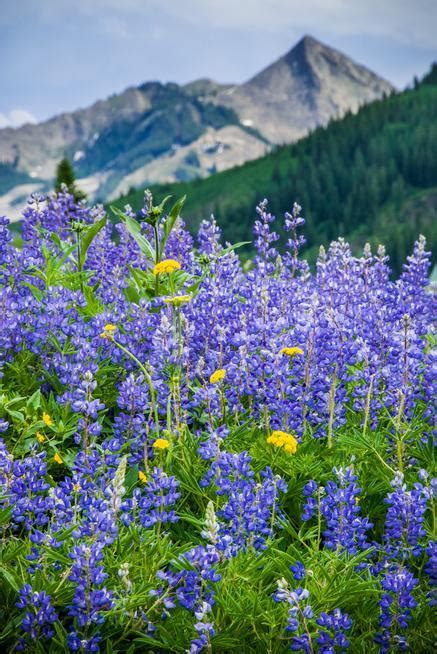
xmin=115 ymin=64 xmax=437 ymax=269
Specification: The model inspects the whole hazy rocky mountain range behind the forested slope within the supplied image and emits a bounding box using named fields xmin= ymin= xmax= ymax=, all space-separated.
xmin=0 ymin=36 xmax=393 ymax=215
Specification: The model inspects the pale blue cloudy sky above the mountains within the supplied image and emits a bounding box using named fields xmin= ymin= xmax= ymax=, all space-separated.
xmin=0 ymin=0 xmax=437 ymax=126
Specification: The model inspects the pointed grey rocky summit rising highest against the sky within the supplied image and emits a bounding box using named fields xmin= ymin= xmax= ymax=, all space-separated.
xmin=218 ymin=34 xmax=393 ymax=143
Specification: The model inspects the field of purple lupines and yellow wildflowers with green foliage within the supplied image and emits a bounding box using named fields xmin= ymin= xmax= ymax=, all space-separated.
xmin=0 ymin=192 xmax=437 ymax=654
